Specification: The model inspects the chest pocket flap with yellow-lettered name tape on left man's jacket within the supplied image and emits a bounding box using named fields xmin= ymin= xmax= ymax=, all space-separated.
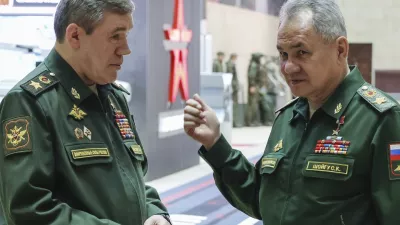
xmin=65 ymin=142 xmax=113 ymax=166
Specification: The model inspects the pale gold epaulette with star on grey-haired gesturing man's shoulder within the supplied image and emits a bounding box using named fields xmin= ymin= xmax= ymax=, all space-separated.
xmin=357 ymin=83 xmax=397 ymax=113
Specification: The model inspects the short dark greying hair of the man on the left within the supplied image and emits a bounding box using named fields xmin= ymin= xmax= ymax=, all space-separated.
xmin=54 ymin=0 xmax=135 ymax=42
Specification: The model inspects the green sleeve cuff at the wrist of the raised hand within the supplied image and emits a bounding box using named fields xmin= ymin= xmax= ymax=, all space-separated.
xmin=199 ymin=134 xmax=232 ymax=169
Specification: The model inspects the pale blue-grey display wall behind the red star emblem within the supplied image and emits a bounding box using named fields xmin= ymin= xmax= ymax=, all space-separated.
xmin=119 ymin=0 xmax=204 ymax=180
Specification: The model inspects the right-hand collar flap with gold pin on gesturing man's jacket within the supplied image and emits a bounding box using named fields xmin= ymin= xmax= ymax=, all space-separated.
xmin=322 ymin=66 xmax=365 ymax=120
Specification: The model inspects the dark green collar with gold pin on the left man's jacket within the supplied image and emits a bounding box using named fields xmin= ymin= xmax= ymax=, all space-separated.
xmin=44 ymin=49 xmax=94 ymax=105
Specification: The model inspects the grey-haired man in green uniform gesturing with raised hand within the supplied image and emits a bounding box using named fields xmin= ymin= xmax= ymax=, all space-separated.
xmin=184 ymin=0 xmax=400 ymax=225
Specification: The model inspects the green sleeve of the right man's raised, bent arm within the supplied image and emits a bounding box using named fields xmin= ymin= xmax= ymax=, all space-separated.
xmin=199 ymin=135 xmax=261 ymax=219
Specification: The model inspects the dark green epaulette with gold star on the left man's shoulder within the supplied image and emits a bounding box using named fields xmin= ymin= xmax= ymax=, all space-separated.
xmin=20 ymin=70 xmax=59 ymax=97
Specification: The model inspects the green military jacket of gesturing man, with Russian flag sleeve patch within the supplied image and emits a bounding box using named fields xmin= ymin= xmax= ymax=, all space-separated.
xmin=199 ymin=68 xmax=400 ymax=225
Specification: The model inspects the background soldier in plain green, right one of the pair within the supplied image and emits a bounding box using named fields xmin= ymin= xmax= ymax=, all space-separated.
xmin=226 ymin=53 xmax=242 ymax=127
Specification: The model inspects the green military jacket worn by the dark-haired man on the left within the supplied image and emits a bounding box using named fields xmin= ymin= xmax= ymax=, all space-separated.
xmin=0 ymin=50 xmax=167 ymax=225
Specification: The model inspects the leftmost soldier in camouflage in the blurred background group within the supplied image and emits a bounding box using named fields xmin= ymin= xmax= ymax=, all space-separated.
xmin=246 ymin=53 xmax=263 ymax=126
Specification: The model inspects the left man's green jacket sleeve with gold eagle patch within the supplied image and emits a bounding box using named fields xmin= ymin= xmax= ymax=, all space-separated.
xmin=0 ymin=90 xmax=117 ymax=225
